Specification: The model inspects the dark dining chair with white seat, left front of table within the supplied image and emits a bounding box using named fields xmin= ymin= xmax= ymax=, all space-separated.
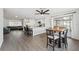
xmin=46 ymin=29 xmax=59 ymax=51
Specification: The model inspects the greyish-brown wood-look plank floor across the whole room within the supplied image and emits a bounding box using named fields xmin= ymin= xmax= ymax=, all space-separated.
xmin=0 ymin=31 xmax=79 ymax=51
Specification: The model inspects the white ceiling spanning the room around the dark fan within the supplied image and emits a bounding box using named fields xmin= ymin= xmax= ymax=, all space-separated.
xmin=4 ymin=8 xmax=75 ymax=19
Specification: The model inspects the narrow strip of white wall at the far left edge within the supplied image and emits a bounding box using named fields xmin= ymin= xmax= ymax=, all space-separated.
xmin=0 ymin=8 xmax=3 ymax=47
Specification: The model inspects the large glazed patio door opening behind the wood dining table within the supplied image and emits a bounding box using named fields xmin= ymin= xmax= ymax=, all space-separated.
xmin=54 ymin=16 xmax=72 ymax=35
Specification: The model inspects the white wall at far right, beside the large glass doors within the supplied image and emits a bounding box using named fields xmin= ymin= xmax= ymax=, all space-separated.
xmin=72 ymin=9 xmax=79 ymax=40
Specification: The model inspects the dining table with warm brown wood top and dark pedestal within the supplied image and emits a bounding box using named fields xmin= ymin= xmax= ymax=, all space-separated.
xmin=49 ymin=27 xmax=65 ymax=48
